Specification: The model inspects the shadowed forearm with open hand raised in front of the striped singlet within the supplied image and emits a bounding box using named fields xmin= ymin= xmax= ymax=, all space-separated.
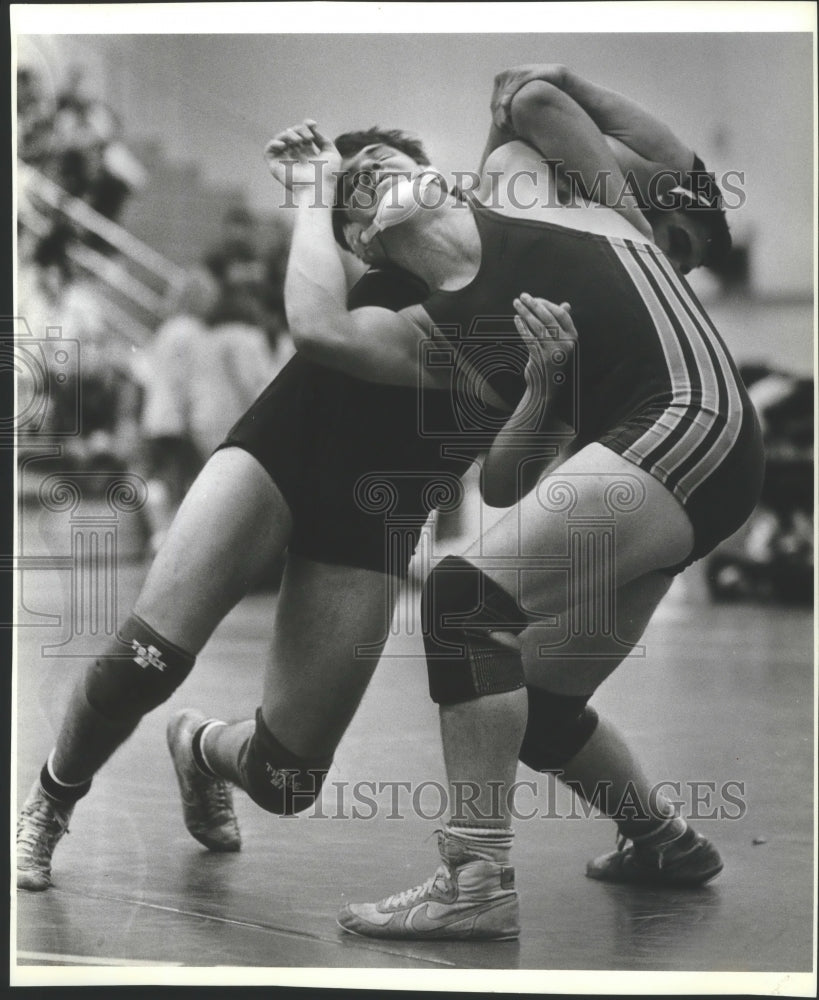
xmin=481 ymin=293 xmax=577 ymax=507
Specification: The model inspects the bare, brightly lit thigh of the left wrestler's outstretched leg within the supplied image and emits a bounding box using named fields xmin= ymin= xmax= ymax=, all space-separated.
xmin=134 ymin=448 xmax=292 ymax=653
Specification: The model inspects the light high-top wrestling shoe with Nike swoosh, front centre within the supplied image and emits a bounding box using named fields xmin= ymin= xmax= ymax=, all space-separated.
xmin=338 ymin=832 xmax=520 ymax=941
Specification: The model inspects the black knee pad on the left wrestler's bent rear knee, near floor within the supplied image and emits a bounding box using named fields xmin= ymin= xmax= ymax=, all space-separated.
xmin=239 ymin=709 xmax=332 ymax=816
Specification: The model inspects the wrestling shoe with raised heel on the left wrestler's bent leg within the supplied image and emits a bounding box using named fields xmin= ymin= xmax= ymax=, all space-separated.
xmin=167 ymin=708 xmax=242 ymax=851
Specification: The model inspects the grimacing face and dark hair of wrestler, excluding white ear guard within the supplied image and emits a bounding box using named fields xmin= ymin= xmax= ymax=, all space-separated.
xmin=333 ymin=128 xmax=438 ymax=263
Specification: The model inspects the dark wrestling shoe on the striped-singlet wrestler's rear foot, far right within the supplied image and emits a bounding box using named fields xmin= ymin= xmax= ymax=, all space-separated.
xmin=586 ymin=817 xmax=723 ymax=886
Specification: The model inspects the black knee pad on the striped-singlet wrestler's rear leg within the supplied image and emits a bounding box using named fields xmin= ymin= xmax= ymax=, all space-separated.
xmin=518 ymin=685 xmax=598 ymax=771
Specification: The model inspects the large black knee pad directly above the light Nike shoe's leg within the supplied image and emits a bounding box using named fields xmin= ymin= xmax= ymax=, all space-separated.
xmin=421 ymin=556 xmax=529 ymax=705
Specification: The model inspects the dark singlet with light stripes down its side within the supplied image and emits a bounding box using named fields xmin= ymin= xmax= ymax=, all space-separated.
xmin=423 ymin=201 xmax=763 ymax=562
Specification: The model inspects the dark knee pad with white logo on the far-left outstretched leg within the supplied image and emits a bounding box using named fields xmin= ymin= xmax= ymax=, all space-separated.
xmin=85 ymin=615 xmax=196 ymax=722
